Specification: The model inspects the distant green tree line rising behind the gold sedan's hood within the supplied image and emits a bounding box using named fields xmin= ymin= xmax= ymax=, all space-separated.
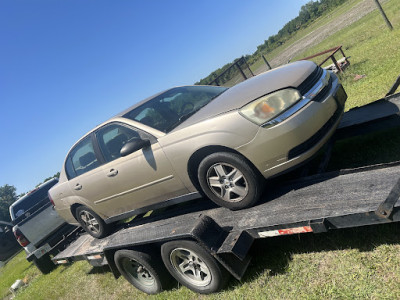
xmin=195 ymin=0 xmax=348 ymax=85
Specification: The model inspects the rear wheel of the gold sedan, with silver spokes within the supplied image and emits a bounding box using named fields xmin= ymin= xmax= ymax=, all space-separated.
xmin=75 ymin=206 xmax=110 ymax=239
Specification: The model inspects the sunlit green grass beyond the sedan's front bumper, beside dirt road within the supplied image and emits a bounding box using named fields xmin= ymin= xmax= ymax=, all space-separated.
xmin=290 ymin=0 xmax=400 ymax=109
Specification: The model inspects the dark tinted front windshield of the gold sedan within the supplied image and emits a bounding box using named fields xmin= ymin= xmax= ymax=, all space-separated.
xmin=124 ymin=86 xmax=227 ymax=133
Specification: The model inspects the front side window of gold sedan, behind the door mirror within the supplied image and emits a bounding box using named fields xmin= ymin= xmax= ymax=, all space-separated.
xmin=96 ymin=123 xmax=141 ymax=162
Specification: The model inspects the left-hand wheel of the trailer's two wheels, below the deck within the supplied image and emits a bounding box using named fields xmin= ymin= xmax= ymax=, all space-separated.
xmin=114 ymin=250 xmax=173 ymax=294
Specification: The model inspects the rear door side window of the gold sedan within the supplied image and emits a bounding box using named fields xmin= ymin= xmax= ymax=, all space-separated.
xmin=65 ymin=136 xmax=100 ymax=179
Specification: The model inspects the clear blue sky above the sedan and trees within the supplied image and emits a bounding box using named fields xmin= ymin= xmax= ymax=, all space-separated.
xmin=0 ymin=0 xmax=309 ymax=193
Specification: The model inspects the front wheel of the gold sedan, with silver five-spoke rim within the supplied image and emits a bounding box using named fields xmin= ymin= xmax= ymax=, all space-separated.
xmin=197 ymin=152 xmax=263 ymax=210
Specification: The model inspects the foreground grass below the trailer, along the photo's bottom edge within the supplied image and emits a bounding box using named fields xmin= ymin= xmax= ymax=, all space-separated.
xmin=1 ymin=224 xmax=400 ymax=300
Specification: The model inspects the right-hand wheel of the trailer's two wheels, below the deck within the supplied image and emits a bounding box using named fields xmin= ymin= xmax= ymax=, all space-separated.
xmin=161 ymin=240 xmax=230 ymax=294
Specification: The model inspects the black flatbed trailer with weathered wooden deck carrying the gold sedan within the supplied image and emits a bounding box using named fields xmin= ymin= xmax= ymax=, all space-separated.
xmin=53 ymin=93 xmax=400 ymax=293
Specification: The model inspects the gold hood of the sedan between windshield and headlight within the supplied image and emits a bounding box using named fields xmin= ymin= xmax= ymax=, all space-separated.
xmin=173 ymin=60 xmax=316 ymax=131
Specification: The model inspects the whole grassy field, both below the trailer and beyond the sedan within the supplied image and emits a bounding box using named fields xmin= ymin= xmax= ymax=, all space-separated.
xmin=0 ymin=0 xmax=400 ymax=299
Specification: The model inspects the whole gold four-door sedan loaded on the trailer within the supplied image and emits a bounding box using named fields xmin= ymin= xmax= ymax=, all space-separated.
xmin=49 ymin=61 xmax=347 ymax=238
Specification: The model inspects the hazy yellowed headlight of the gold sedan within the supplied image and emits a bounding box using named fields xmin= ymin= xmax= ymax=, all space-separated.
xmin=240 ymin=88 xmax=302 ymax=125
